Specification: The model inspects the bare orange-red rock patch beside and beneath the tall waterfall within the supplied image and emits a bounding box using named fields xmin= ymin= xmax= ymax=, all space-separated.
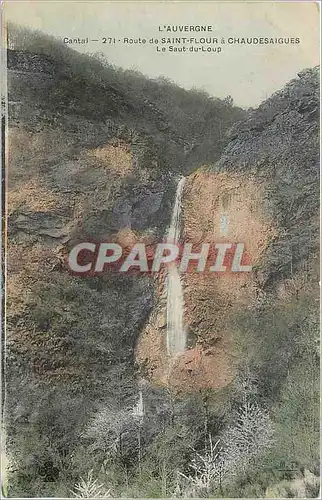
xmin=136 ymin=172 xmax=276 ymax=392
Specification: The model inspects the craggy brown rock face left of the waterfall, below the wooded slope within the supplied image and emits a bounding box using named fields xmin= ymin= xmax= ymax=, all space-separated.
xmin=8 ymin=49 xmax=177 ymax=398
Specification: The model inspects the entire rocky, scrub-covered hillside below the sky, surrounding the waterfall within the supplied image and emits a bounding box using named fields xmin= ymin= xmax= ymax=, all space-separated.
xmin=5 ymin=26 xmax=319 ymax=498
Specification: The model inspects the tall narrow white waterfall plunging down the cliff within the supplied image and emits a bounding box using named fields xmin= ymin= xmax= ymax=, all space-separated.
xmin=167 ymin=177 xmax=186 ymax=357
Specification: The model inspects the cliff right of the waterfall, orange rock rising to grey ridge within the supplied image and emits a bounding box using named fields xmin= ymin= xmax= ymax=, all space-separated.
xmin=138 ymin=69 xmax=319 ymax=391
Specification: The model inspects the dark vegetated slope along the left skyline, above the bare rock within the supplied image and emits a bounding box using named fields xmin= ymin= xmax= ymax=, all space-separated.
xmin=8 ymin=24 xmax=245 ymax=171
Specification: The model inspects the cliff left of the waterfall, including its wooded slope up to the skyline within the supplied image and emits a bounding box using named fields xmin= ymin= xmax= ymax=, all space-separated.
xmin=7 ymin=30 xmax=243 ymax=484
